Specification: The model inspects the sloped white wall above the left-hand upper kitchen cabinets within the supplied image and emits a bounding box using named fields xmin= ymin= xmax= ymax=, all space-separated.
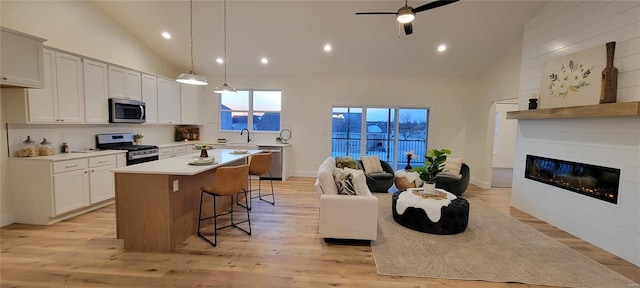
xmin=0 ymin=1 xmax=180 ymax=78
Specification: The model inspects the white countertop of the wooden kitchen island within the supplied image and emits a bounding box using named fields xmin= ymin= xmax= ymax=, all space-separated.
xmin=111 ymin=149 xmax=260 ymax=175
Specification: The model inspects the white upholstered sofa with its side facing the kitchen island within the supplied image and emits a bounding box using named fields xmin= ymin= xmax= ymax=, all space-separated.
xmin=315 ymin=157 xmax=378 ymax=240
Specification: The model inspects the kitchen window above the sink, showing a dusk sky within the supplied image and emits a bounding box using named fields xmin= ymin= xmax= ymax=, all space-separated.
xmin=220 ymin=90 xmax=282 ymax=131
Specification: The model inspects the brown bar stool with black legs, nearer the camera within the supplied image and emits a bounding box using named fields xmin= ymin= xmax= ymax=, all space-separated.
xmin=198 ymin=164 xmax=251 ymax=247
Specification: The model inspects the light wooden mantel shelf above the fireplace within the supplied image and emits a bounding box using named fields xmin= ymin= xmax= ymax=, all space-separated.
xmin=507 ymin=101 xmax=640 ymax=119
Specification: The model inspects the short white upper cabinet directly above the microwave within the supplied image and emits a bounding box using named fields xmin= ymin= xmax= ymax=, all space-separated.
xmin=109 ymin=65 xmax=142 ymax=100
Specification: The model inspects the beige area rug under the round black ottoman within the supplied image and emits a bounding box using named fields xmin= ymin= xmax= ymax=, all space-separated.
xmin=371 ymin=194 xmax=636 ymax=287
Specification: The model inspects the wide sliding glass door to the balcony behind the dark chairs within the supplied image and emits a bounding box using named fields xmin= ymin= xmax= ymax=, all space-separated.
xmin=331 ymin=107 xmax=429 ymax=170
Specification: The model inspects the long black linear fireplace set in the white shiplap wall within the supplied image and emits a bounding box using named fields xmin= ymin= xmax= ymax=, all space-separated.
xmin=524 ymin=155 xmax=620 ymax=204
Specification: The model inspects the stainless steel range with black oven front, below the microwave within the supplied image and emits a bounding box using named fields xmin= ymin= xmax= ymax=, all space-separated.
xmin=96 ymin=133 xmax=159 ymax=165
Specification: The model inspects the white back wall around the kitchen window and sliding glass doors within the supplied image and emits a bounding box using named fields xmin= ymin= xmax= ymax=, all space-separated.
xmin=200 ymin=75 xmax=478 ymax=177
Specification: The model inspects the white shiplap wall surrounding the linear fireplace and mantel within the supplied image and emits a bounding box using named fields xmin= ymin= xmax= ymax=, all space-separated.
xmin=511 ymin=1 xmax=640 ymax=265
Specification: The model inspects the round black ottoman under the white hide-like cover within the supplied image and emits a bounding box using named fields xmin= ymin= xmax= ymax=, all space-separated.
xmin=391 ymin=191 xmax=469 ymax=235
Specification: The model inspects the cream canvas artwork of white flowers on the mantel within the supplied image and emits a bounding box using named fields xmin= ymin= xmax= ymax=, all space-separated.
xmin=538 ymin=45 xmax=607 ymax=108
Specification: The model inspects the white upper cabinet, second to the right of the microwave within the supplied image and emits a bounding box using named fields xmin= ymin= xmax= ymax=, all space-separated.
xmin=158 ymin=77 xmax=181 ymax=124
